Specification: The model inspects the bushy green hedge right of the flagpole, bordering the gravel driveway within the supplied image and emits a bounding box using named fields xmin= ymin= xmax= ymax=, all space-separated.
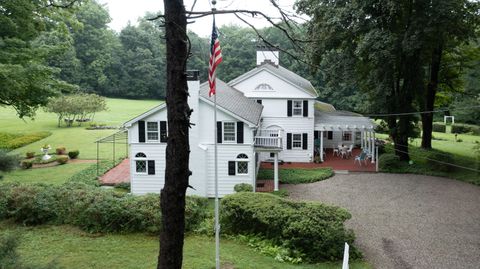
xmin=221 ymin=192 xmax=361 ymax=262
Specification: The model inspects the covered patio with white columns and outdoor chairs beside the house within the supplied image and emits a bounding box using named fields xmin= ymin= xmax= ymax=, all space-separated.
xmin=314 ymin=111 xmax=378 ymax=163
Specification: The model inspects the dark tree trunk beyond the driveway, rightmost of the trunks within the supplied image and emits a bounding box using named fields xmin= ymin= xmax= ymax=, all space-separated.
xmin=422 ymin=43 xmax=443 ymax=149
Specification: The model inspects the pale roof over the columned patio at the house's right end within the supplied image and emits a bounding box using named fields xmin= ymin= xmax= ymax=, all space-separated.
xmin=315 ymin=110 xmax=376 ymax=131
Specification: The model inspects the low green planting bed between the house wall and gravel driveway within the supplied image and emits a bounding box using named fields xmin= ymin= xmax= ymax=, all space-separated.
xmin=257 ymin=167 xmax=333 ymax=184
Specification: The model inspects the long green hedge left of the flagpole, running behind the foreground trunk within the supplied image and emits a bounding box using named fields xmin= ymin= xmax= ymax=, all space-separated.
xmin=0 ymin=183 xmax=208 ymax=233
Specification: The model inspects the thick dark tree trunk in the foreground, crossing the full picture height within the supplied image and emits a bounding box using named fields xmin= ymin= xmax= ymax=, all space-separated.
xmin=157 ymin=0 xmax=191 ymax=269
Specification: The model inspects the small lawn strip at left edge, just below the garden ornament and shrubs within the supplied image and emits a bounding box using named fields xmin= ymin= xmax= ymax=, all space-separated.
xmin=2 ymin=163 xmax=92 ymax=185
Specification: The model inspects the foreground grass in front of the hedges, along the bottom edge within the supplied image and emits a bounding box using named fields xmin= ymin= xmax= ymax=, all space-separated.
xmin=0 ymin=222 xmax=371 ymax=269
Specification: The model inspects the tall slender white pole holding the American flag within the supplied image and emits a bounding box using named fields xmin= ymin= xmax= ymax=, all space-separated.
xmin=212 ymin=0 xmax=220 ymax=269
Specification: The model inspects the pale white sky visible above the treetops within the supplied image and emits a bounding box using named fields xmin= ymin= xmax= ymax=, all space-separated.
xmin=98 ymin=0 xmax=300 ymax=37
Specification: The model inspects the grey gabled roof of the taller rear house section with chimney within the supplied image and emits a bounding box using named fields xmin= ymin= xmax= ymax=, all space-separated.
xmin=228 ymin=62 xmax=318 ymax=97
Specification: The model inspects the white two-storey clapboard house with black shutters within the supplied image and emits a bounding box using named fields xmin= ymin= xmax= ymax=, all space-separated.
xmin=124 ymin=49 xmax=375 ymax=197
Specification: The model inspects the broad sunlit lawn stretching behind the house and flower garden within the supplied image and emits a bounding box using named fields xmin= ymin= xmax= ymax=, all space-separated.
xmin=0 ymin=98 xmax=162 ymax=159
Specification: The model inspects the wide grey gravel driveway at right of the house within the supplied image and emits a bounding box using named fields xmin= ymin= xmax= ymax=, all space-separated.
xmin=282 ymin=174 xmax=480 ymax=269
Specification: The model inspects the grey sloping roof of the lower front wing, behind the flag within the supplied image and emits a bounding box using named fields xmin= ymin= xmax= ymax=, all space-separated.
xmin=200 ymin=78 xmax=263 ymax=125
